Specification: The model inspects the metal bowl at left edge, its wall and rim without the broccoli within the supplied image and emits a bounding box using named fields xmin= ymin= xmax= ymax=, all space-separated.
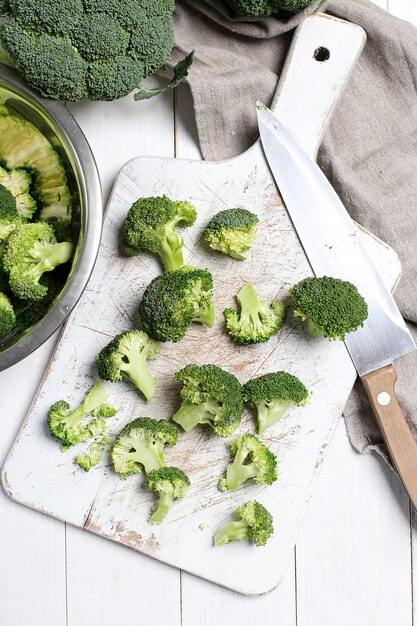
xmin=0 ymin=64 xmax=103 ymax=371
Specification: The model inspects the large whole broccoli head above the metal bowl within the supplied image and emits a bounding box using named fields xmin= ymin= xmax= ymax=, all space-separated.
xmin=1 ymin=0 xmax=174 ymax=101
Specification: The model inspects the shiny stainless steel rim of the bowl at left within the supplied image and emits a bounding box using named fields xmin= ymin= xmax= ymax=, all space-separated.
xmin=0 ymin=64 xmax=103 ymax=371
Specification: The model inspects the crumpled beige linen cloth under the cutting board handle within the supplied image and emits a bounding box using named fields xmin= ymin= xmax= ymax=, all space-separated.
xmin=173 ymin=0 xmax=417 ymax=462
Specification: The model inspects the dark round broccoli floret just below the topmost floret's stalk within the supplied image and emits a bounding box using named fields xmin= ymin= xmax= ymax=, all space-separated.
xmin=139 ymin=265 xmax=214 ymax=341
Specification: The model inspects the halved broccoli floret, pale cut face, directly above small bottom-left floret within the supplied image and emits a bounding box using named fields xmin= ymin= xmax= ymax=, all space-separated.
xmin=111 ymin=417 xmax=178 ymax=478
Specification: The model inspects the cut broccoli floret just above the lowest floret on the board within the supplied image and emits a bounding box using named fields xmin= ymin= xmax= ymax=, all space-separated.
xmin=218 ymin=434 xmax=278 ymax=491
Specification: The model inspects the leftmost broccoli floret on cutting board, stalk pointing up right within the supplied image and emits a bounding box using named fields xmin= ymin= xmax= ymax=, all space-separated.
xmin=48 ymin=380 xmax=111 ymax=448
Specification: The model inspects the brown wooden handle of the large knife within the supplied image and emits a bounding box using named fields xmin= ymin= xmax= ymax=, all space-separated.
xmin=362 ymin=365 xmax=417 ymax=509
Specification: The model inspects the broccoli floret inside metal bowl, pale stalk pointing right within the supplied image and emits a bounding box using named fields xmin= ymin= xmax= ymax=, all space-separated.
xmin=3 ymin=222 xmax=74 ymax=300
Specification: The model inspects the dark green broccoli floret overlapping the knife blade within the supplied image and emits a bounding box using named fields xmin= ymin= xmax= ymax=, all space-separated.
xmin=291 ymin=276 xmax=368 ymax=341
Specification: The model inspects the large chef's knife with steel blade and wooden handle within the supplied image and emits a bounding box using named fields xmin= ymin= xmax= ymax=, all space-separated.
xmin=257 ymin=103 xmax=417 ymax=508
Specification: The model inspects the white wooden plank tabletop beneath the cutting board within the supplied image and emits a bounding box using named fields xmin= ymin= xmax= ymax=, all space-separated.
xmin=0 ymin=0 xmax=417 ymax=626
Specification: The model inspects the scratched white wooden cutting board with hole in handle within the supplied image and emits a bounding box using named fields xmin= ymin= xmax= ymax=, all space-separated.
xmin=2 ymin=16 xmax=390 ymax=594
